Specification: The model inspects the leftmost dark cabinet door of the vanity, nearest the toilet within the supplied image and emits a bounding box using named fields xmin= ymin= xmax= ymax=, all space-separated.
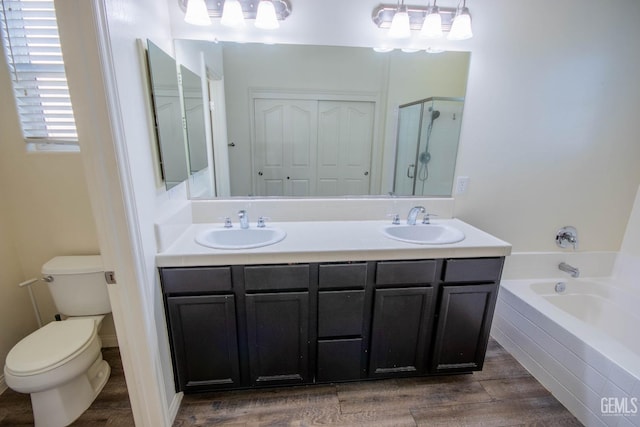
xmin=167 ymin=295 xmax=240 ymax=391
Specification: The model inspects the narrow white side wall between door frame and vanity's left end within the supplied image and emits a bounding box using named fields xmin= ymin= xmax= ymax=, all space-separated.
xmin=89 ymin=0 xmax=184 ymax=414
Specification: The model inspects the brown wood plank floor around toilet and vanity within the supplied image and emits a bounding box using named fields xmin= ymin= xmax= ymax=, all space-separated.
xmin=0 ymin=340 xmax=581 ymax=427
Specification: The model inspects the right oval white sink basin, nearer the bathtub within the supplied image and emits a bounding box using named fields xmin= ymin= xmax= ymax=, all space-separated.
xmin=382 ymin=224 xmax=465 ymax=245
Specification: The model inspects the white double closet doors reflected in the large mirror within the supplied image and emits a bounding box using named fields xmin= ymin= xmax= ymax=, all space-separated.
xmin=252 ymin=99 xmax=375 ymax=196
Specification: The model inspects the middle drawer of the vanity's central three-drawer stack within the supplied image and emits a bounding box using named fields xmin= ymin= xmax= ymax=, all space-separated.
xmin=318 ymin=291 xmax=364 ymax=338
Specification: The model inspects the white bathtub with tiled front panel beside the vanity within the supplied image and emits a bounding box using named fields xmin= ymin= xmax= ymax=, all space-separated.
xmin=491 ymin=278 xmax=640 ymax=427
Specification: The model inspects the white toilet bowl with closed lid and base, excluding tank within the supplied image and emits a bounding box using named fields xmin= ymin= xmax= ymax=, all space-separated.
xmin=4 ymin=318 xmax=111 ymax=427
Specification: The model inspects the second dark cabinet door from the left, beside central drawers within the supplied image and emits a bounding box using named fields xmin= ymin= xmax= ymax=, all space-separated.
xmin=246 ymin=292 xmax=309 ymax=385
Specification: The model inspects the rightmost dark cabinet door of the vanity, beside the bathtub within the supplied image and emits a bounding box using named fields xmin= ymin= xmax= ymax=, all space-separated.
xmin=432 ymin=283 xmax=498 ymax=372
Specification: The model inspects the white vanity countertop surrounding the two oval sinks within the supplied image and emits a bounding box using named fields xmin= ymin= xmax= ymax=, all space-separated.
xmin=156 ymin=219 xmax=511 ymax=267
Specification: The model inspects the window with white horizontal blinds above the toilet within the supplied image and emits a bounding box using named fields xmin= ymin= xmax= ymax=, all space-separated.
xmin=0 ymin=0 xmax=78 ymax=149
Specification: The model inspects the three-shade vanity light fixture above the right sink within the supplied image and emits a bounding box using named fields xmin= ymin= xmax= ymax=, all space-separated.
xmin=371 ymin=0 xmax=473 ymax=40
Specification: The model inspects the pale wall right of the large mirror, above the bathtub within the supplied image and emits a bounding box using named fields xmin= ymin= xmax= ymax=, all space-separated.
xmin=456 ymin=0 xmax=640 ymax=251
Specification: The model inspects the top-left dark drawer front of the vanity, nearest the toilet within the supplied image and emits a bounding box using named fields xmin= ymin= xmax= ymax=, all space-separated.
xmin=160 ymin=267 xmax=232 ymax=294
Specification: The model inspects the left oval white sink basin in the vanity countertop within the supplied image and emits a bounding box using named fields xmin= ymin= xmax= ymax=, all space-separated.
xmin=196 ymin=227 xmax=287 ymax=249
